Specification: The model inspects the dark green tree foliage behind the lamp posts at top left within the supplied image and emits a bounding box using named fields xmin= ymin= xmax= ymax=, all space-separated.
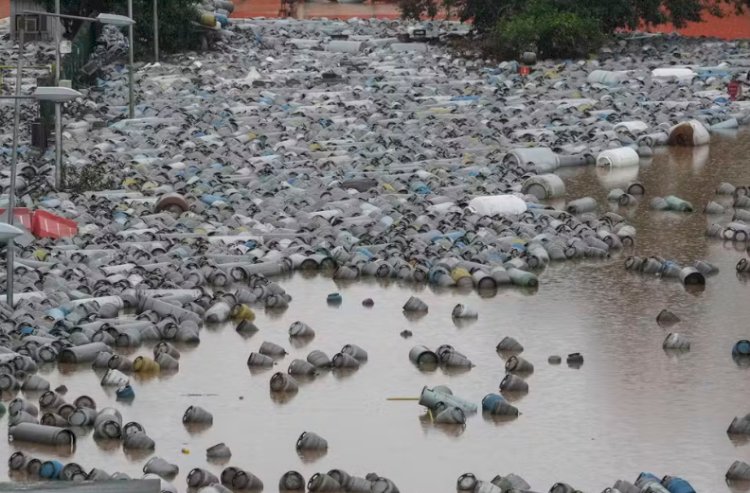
xmin=42 ymin=0 xmax=199 ymax=56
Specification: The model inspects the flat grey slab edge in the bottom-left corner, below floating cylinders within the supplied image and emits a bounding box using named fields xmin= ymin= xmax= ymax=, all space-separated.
xmin=0 ymin=479 xmax=161 ymax=493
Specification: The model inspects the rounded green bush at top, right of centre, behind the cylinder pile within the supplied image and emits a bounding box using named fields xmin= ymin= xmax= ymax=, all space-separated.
xmin=488 ymin=2 xmax=604 ymax=59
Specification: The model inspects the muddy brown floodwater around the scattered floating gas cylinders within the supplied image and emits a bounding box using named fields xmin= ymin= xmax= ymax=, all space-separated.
xmin=0 ymin=132 xmax=750 ymax=493
